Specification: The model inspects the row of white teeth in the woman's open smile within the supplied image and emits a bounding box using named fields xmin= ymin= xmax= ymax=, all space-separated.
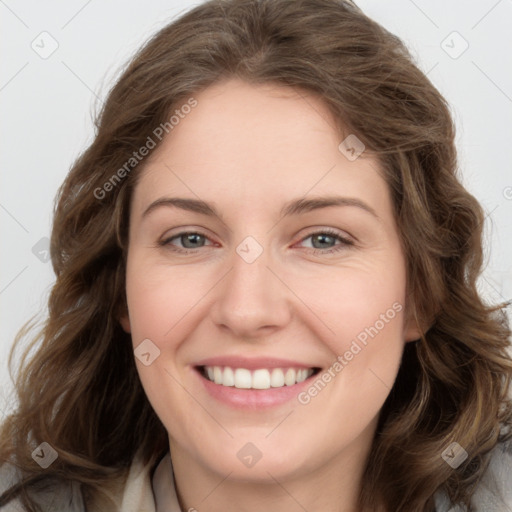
xmin=204 ymin=366 xmax=314 ymax=389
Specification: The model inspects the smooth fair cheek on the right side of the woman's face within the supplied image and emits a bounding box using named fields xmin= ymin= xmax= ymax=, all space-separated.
xmin=299 ymin=275 xmax=405 ymax=440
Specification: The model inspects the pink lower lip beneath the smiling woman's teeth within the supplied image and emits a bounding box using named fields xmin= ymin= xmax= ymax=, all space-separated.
xmin=194 ymin=368 xmax=317 ymax=409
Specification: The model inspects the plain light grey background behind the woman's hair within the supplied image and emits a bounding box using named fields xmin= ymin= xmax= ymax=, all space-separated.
xmin=0 ymin=0 xmax=512 ymax=420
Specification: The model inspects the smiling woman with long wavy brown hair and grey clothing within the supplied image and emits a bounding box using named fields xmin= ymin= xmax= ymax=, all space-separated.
xmin=0 ymin=0 xmax=512 ymax=512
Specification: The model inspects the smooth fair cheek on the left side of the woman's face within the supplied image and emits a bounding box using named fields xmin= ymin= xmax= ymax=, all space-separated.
xmin=126 ymin=262 xmax=204 ymax=439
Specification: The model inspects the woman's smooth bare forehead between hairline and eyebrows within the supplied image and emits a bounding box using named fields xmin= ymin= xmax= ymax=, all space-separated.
xmin=130 ymin=80 xmax=389 ymax=216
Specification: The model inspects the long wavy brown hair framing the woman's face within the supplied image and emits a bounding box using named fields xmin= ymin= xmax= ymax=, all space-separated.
xmin=0 ymin=0 xmax=512 ymax=512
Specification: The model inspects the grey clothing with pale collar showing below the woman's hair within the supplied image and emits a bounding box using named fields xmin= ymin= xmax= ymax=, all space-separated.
xmin=0 ymin=440 xmax=512 ymax=512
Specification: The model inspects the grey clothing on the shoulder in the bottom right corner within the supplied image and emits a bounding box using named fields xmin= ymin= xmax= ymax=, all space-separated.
xmin=435 ymin=438 xmax=512 ymax=512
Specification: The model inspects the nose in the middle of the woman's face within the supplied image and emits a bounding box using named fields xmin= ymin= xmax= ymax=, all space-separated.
xmin=211 ymin=242 xmax=293 ymax=340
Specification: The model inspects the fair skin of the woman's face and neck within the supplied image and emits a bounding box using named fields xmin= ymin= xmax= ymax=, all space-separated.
xmin=121 ymin=80 xmax=419 ymax=512
